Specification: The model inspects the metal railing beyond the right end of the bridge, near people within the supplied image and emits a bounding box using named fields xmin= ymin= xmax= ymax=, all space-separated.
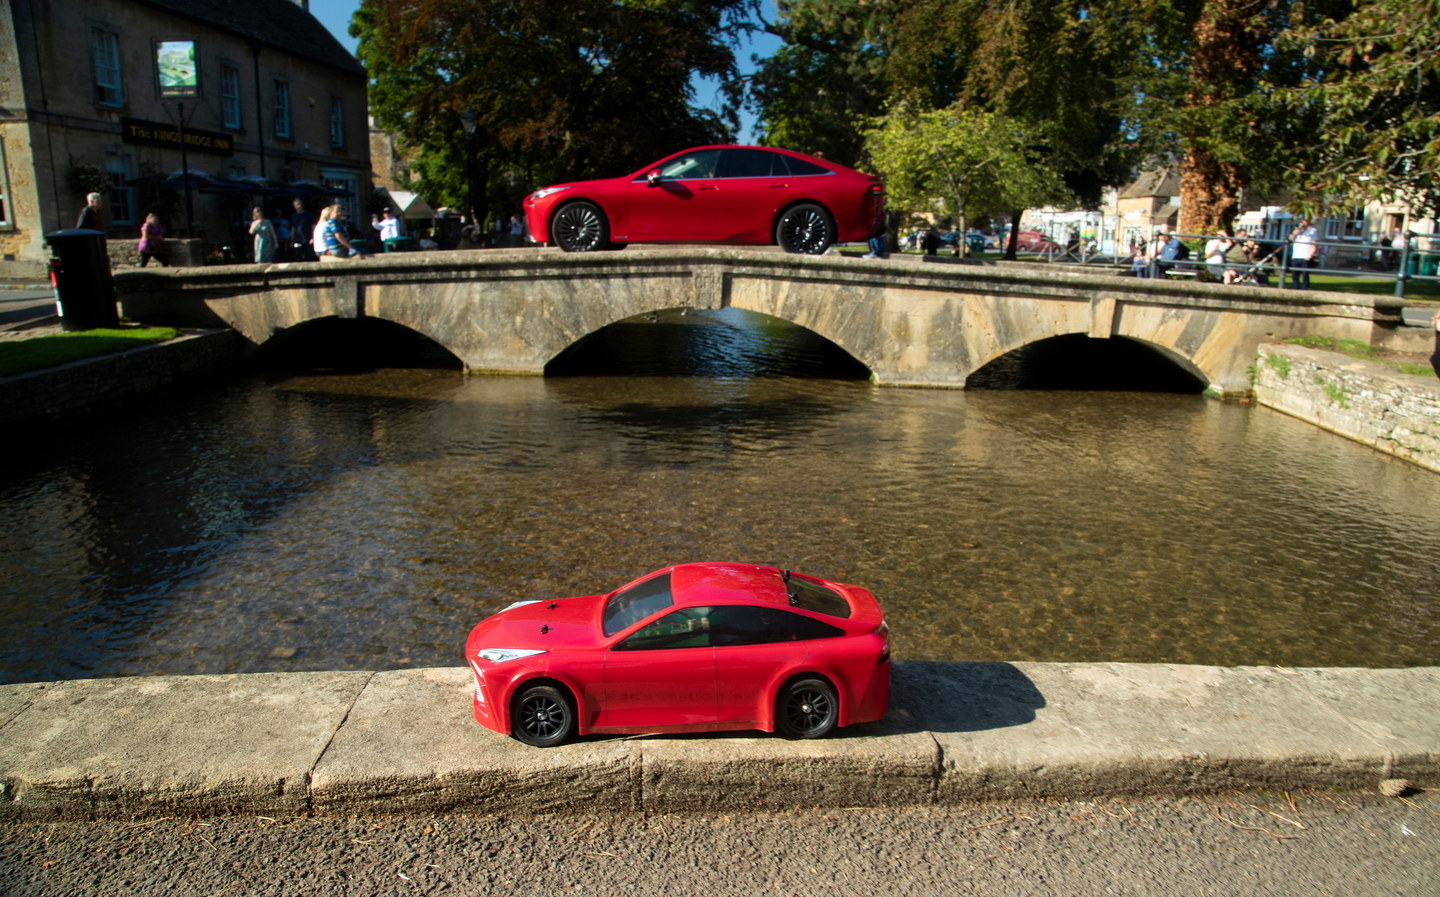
xmin=1040 ymin=232 xmax=1440 ymax=298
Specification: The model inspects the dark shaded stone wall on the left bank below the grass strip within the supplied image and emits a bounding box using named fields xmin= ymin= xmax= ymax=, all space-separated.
xmin=0 ymin=331 xmax=246 ymax=425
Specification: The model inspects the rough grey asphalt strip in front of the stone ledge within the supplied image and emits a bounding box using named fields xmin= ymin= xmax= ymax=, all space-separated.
xmin=0 ymin=793 xmax=1440 ymax=897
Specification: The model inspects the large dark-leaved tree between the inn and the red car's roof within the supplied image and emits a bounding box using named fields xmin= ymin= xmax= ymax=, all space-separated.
xmin=350 ymin=0 xmax=755 ymax=215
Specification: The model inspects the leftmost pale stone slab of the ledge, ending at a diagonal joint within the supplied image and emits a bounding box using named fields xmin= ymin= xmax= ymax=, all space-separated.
xmin=0 ymin=672 xmax=373 ymax=819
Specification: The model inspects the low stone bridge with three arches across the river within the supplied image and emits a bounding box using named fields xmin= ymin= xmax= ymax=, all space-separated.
xmin=115 ymin=248 xmax=1401 ymax=396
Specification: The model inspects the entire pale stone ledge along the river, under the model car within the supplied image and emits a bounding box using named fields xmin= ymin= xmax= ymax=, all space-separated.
xmin=0 ymin=661 xmax=1440 ymax=819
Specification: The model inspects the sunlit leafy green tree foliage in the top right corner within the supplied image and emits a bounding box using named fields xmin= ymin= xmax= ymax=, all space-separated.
xmin=1272 ymin=0 xmax=1440 ymax=216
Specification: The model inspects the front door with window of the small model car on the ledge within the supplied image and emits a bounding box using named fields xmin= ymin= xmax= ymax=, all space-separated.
xmin=596 ymin=608 xmax=716 ymax=729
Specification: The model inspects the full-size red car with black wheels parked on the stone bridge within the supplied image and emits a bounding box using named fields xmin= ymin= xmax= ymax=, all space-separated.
xmin=524 ymin=147 xmax=886 ymax=255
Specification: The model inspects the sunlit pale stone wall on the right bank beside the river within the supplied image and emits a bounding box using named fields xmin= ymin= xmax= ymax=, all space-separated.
xmin=1254 ymin=343 xmax=1440 ymax=472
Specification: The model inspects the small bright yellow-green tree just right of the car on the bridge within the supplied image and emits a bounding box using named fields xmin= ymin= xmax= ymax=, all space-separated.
xmin=865 ymin=102 xmax=1064 ymax=241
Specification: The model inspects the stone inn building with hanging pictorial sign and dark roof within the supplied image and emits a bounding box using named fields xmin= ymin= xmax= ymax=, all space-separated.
xmin=0 ymin=0 xmax=370 ymax=276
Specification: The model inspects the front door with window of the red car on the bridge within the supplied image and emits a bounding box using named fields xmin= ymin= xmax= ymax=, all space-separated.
xmin=615 ymin=150 xmax=721 ymax=242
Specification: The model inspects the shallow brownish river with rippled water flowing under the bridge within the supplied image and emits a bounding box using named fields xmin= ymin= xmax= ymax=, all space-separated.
xmin=0 ymin=308 xmax=1440 ymax=681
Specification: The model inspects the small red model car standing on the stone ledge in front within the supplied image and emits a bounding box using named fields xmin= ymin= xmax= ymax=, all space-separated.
xmin=465 ymin=563 xmax=890 ymax=747
